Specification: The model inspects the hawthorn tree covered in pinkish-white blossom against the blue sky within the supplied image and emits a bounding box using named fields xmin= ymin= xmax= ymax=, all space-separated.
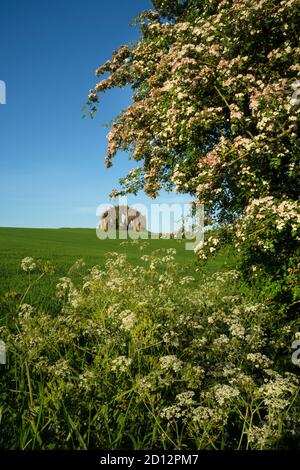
xmin=88 ymin=0 xmax=300 ymax=303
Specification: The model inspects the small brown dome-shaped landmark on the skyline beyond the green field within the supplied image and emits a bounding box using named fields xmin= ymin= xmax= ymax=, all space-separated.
xmin=99 ymin=206 xmax=147 ymax=232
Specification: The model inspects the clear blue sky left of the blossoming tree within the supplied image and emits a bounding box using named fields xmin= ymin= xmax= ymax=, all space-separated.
xmin=0 ymin=0 xmax=189 ymax=227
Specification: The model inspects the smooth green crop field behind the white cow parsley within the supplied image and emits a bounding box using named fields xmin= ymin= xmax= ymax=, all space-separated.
xmin=0 ymin=228 xmax=234 ymax=307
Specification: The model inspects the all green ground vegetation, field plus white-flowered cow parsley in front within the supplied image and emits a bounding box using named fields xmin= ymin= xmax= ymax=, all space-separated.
xmin=0 ymin=229 xmax=299 ymax=450
